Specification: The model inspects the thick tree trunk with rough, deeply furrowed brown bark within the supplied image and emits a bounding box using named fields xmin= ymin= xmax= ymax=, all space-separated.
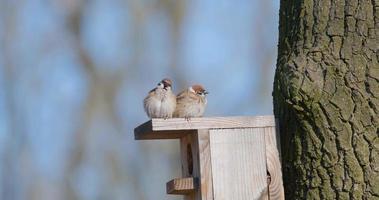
xmin=273 ymin=0 xmax=379 ymax=200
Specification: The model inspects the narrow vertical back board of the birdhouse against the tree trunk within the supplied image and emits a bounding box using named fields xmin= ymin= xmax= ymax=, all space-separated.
xmin=264 ymin=127 xmax=284 ymax=200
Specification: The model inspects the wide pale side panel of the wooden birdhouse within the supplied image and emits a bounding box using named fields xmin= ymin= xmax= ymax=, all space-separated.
xmin=210 ymin=128 xmax=268 ymax=200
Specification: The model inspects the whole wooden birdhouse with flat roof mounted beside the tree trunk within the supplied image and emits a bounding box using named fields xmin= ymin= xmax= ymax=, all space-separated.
xmin=134 ymin=116 xmax=284 ymax=200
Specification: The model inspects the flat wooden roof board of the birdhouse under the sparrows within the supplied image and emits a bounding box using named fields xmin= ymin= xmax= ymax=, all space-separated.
xmin=134 ymin=115 xmax=275 ymax=140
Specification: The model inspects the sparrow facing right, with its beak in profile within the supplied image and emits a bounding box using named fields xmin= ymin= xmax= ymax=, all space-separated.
xmin=174 ymin=85 xmax=208 ymax=120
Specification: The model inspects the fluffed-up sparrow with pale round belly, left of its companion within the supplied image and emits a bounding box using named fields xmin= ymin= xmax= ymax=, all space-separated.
xmin=143 ymin=78 xmax=176 ymax=119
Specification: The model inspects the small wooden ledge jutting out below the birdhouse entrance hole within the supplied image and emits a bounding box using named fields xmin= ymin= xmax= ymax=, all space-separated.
xmin=166 ymin=177 xmax=197 ymax=195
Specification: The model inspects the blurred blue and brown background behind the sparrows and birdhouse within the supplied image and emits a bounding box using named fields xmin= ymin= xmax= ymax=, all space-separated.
xmin=0 ymin=0 xmax=278 ymax=200
